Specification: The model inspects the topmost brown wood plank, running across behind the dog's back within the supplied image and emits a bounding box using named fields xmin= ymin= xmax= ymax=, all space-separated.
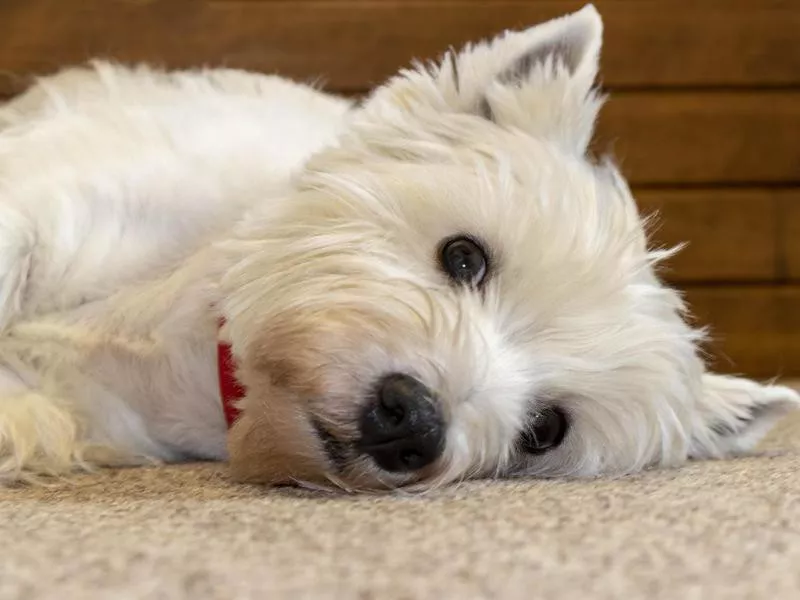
xmin=0 ymin=0 xmax=800 ymax=95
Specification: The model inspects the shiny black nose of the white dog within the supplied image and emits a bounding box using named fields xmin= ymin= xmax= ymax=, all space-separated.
xmin=359 ymin=373 xmax=444 ymax=472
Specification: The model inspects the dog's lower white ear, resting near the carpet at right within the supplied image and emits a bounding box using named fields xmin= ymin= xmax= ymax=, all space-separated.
xmin=689 ymin=374 xmax=800 ymax=458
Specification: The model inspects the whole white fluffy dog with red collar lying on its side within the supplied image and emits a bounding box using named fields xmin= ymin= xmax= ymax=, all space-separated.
xmin=0 ymin=6 xmax=800 ymax=490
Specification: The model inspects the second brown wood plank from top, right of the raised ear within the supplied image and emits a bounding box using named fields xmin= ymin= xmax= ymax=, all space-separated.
xmin=596 ymin=91 xmax=800 ymax=185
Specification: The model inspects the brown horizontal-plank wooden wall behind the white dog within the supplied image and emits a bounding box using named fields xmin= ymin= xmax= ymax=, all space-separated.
xmin=0 ymin=0 xmax=800 ymax=376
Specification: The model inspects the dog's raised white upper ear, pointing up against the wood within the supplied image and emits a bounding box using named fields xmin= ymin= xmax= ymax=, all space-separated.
xmin=367 ymin=4 xmax=603 ymax=154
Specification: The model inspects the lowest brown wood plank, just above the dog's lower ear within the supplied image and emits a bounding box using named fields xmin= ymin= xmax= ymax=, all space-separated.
xmin=686 ymin=286 xmax=800 ymax=378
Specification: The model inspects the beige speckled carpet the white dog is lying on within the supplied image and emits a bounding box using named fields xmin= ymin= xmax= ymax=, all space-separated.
xmin=0 ymin=416 xmax=800 ymax=600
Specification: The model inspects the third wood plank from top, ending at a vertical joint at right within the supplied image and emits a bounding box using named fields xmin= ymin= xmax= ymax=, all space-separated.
xmin=634 ymin=189 xmax=788 ymax=282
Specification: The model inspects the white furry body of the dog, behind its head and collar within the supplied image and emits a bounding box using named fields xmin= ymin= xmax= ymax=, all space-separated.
xmin=0 ymin=63 xmax=349 ymax=476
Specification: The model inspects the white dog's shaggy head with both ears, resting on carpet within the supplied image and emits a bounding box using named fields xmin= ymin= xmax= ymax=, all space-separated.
xmin=222 ymin=7 xmax=797 ymax=489
